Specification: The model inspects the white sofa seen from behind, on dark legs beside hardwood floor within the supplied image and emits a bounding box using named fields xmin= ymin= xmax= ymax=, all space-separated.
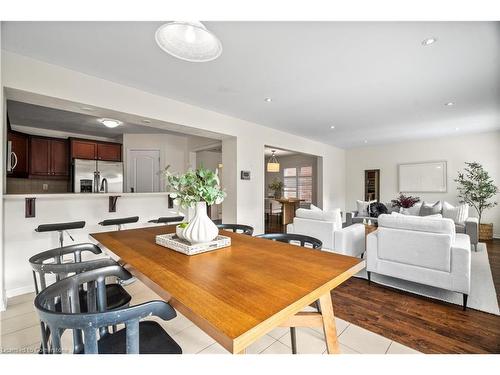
xmin=366 ymin=215 xmax=471 ymax=310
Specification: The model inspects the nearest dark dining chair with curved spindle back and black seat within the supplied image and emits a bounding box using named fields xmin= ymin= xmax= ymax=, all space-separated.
xmin=35 ymin=265 xmax=182 ymax=354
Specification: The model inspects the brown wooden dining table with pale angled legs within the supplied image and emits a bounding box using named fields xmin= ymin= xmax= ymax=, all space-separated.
xmin=90 ymin=226 xmax=365 ymax=353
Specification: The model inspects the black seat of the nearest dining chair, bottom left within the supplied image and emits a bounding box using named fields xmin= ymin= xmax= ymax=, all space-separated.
xmin=98 ymin=321 xmax=182 ymax=354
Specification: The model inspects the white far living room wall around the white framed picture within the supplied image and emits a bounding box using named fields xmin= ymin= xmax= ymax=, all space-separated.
xmin=346 ymin=131 xmax=500 ymax=237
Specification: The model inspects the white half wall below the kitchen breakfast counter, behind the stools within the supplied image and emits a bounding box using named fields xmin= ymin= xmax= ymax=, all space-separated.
xmin=3 ymin=193 xmax=182 ymax=297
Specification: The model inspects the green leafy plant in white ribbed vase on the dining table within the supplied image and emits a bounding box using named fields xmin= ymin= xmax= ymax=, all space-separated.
xmin=164 ymin=166 xmax=226 ymax=244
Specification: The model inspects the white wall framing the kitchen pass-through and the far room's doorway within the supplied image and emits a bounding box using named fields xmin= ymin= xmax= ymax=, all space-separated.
xmin=2 ymin=51 xmax=345 ymax=233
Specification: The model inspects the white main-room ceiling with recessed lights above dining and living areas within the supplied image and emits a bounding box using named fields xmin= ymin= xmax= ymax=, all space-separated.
xmin=2 ymin=22 xmax=500 ymax=147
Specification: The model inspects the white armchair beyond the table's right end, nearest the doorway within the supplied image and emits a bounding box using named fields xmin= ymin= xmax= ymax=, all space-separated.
xmin=286 ymin=208 xmax=365 ymax=257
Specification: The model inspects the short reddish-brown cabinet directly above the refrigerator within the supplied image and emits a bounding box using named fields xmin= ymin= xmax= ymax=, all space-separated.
xmin=70 ymin=138 xmax=122 ymax=161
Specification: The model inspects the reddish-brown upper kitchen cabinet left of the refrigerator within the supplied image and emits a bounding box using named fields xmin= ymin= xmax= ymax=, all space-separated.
xmin=29 ymin=136 xmax=69 ymax=179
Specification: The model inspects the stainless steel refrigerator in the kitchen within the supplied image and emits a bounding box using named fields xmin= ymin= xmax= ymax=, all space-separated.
xmin=73 ymin=159 xmax=123 ymax=193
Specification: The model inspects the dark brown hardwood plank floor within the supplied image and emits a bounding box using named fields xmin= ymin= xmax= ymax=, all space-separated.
xmin=266 ymin=217 xmax=500 ymax=353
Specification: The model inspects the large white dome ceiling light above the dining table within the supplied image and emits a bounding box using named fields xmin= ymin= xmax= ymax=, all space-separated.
xmin=155 ymin=21 xmax=222 ymax=62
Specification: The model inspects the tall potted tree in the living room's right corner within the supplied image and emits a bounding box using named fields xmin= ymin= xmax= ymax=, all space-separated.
xmin=455 ymin=162 xmax=498 ymax=240
